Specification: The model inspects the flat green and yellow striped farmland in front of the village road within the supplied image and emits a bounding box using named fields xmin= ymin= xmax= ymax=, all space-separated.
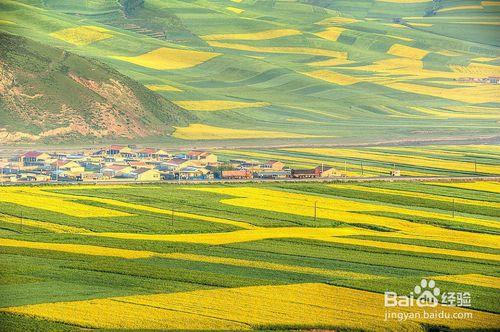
xmin=0 ymin=182 xmax=500 ymax=331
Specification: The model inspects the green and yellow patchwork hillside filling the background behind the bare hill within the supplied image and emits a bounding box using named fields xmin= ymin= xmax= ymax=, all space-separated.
xmin=0 ymin=0 xmax=500 ymax=146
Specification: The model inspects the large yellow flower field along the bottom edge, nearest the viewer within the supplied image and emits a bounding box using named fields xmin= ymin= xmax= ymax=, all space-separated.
xmin=1 ymin=283 xmax=498 ymax=331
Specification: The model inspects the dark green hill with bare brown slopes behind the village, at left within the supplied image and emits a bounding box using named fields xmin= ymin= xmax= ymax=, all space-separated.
xmin=0 ymin=33 xmax=195 ymax=143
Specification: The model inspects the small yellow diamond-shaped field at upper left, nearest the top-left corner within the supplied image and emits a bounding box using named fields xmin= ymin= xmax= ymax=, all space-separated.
xmin=50 ymin=25 xmax=113 ymax=46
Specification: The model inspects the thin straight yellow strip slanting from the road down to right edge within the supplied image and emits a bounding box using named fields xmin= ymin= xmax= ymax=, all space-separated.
xmin=329 ymin=184 xmax=500 ymax=209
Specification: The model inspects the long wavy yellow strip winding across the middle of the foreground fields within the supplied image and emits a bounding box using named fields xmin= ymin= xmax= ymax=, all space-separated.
xmin=86 ymin=227 xmax=379 ymax=245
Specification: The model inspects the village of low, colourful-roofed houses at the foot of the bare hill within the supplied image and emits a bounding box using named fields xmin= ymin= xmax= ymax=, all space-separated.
xmin=0 ymin=145 xmax=390 ymax=183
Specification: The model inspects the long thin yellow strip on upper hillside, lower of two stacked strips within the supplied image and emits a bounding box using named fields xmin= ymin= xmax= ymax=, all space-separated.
xmin=208 ymin=41 xmax=347 ymax=59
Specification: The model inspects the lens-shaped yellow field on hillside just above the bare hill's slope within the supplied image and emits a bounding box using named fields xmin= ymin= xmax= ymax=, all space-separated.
xmin=113 ymin=47 xmax=220 ymax=70
